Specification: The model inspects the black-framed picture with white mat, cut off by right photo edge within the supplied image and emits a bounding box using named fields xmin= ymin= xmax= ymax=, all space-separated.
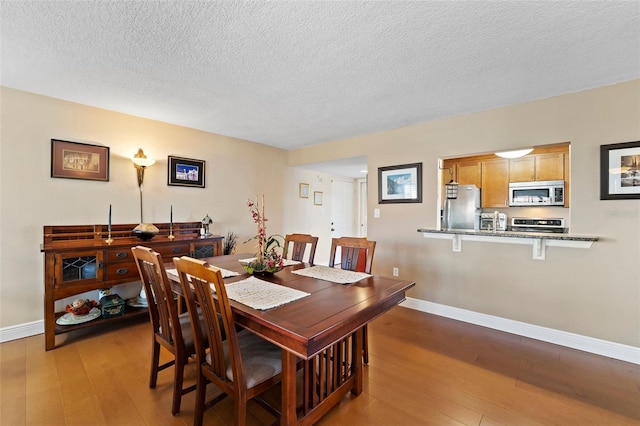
xmin=600 ymin=141 xmax=640 ymax=200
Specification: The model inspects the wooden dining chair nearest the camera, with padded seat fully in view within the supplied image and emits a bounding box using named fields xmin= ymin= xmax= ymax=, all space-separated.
xmin=173 ymin=256 xmax=282 ymax=426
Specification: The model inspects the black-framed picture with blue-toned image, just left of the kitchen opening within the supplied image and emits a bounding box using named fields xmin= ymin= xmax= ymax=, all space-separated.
xmin=378 ymin=163 xmax=422 ymax=204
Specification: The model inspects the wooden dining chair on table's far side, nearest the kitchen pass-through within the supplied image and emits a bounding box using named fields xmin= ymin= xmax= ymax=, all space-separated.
xmin=329 ymin=237 xmax=376 ymax=365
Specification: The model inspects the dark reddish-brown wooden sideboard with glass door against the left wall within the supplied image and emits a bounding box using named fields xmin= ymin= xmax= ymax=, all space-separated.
xmin=40 ymin=222 xmax=223 ymax=350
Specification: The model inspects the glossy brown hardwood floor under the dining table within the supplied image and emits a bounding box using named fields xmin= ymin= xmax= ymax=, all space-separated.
xmin=0 ymin=307 xmax=640 ymax=426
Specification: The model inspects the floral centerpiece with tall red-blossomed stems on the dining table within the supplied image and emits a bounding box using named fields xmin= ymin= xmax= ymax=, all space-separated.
xmin=244 ymin=195 xmax=284 ymax=274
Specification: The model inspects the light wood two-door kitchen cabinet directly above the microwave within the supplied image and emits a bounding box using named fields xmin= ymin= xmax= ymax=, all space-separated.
xmin=509 ymin=152 xmax=564 ymax=182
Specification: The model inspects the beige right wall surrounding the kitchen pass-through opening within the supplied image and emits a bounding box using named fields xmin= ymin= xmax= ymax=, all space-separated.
xmin=289 ymin=80 xmax=640 ymax=347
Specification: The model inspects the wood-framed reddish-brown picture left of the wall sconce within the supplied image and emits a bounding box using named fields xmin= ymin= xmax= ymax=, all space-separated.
xmin=51 ymin=139 xmax=109 ymax=182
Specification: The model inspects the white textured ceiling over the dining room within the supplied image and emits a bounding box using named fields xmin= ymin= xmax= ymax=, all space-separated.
xmin=0 ymin=1 xmax=640 ymax=155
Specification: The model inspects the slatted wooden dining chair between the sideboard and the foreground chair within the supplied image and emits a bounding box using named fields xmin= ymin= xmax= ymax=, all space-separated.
xmin=131 ymin=246 xmax=200 ymax=415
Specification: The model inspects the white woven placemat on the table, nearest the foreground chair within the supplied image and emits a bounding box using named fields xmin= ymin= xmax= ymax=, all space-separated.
xmin=220 ymin=276 xmax=311 ymax=311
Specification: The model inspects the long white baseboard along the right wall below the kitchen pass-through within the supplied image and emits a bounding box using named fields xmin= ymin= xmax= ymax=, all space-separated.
xmin=400 ymin=297 xmax=640 ymax=364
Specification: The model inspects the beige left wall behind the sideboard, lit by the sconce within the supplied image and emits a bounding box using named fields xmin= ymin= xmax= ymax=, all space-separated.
xmin=0 ymin=88 xmax=287 ymax=328
